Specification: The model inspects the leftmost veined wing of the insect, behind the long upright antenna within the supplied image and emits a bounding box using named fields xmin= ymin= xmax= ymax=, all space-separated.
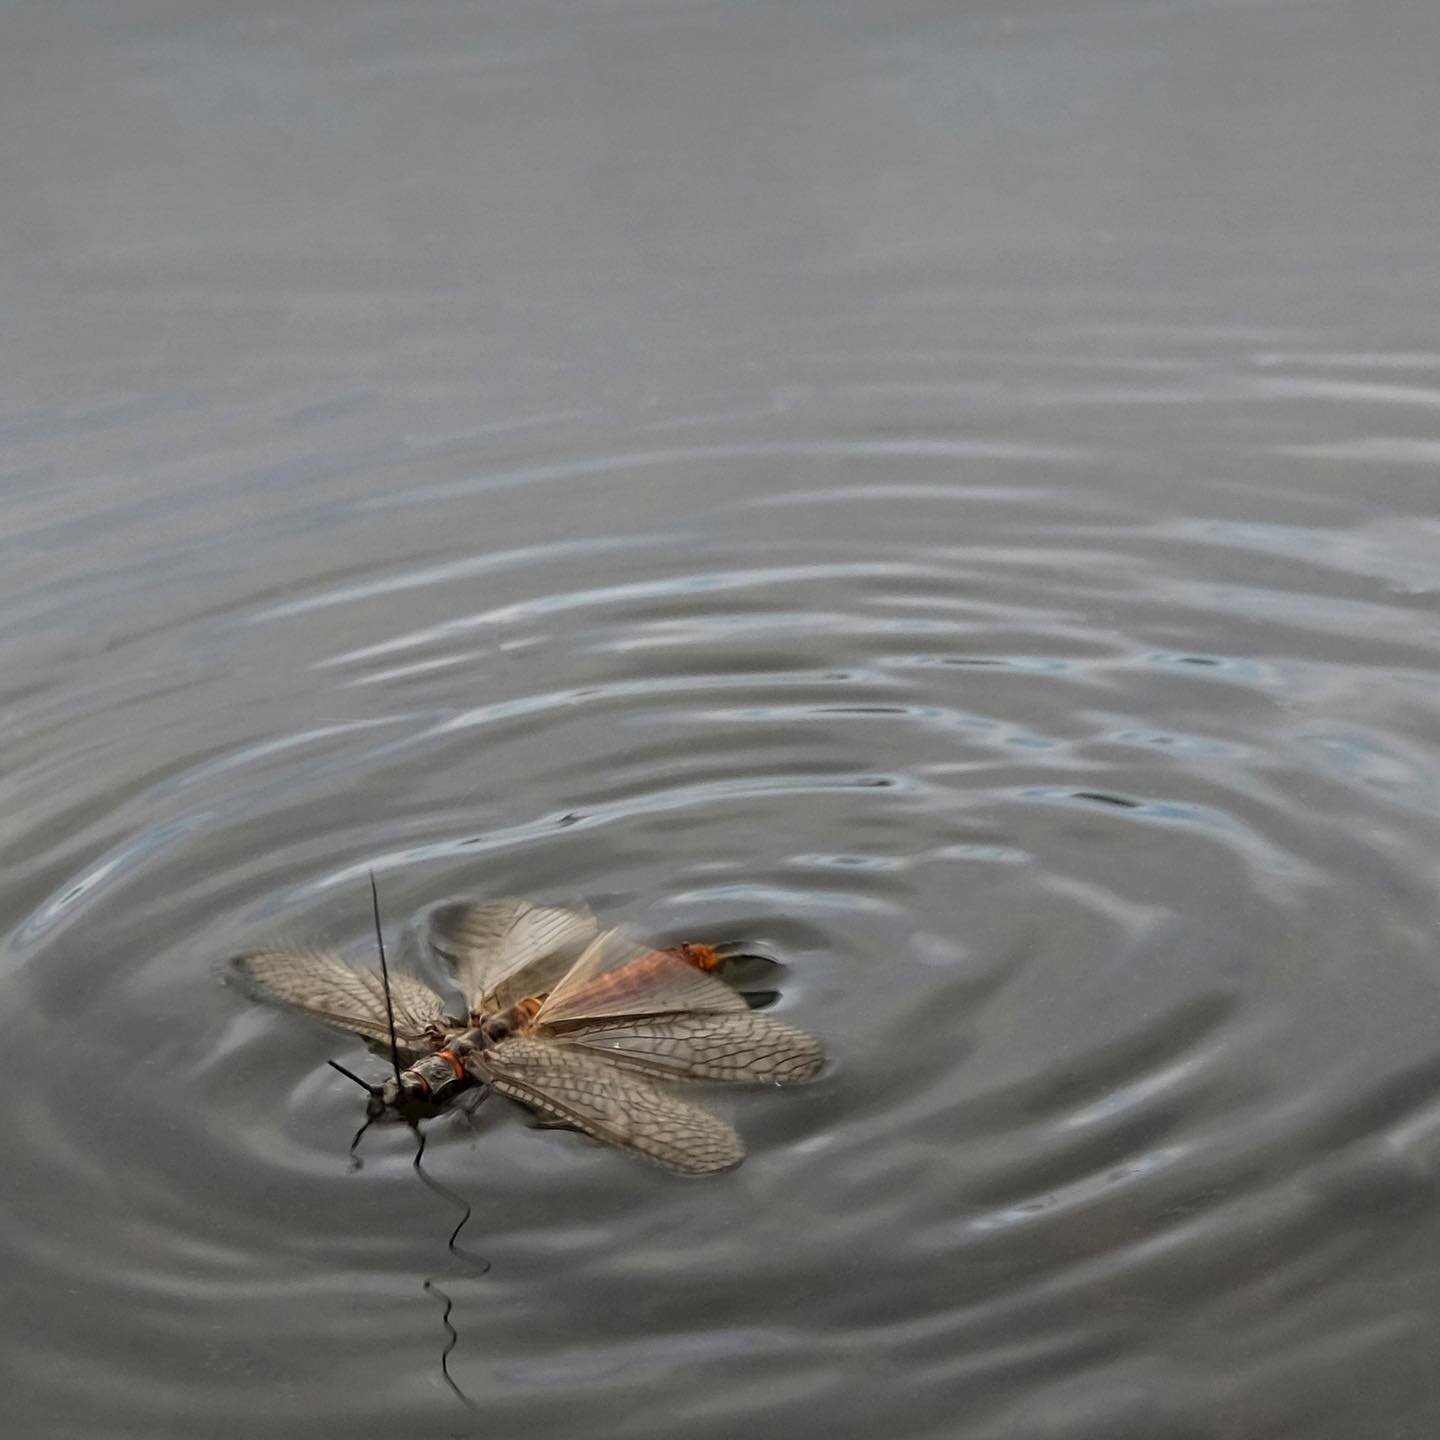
xmin=232 ymin=949 xmax=445 ymax=1056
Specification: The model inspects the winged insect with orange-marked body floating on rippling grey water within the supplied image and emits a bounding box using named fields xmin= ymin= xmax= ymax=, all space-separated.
xmin=233 ymin=878 xmax=825 ymax=1175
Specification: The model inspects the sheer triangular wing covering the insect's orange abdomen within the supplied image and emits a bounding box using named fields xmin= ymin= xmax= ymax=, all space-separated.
xmin=536 ymin=929 xmax=749 ymax=1027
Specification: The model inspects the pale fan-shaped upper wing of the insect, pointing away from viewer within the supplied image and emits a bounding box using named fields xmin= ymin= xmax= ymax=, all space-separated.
xmin=408 ymin=897 xmax=596 ymax=1012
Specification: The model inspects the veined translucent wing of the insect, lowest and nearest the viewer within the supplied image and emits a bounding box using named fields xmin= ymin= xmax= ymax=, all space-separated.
xmin=469 ymin=1035 xmax=744 ymax=1175
